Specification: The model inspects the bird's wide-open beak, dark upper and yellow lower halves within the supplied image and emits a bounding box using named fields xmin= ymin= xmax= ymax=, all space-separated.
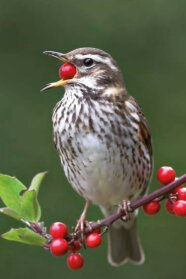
xmin=41 ymin=51 xmax=68 ymax=91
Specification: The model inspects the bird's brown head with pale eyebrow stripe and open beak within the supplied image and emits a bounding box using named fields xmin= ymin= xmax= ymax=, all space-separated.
xmin=43 ymin=48 xmax=124 ymax=99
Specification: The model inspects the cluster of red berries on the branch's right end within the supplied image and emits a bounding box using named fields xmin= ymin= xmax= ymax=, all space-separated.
xmin=143 ymin=167 xmax=186 ymax=216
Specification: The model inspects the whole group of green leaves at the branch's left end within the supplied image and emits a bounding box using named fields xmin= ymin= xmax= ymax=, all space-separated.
xmin=0 ymin=172 xmax=46 ymax=246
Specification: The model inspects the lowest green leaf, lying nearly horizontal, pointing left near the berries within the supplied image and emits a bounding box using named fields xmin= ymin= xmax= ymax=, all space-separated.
xmin=1 ymin=228 xmax=46 ymax=246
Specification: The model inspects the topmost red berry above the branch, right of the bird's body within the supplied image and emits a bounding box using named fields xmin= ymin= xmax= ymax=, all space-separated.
xmin=157 ymin=167 xmax=176 ymax=185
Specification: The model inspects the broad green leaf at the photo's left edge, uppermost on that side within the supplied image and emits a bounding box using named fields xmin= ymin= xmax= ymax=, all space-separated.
xmin=0 ymin=175 xmax=26 ymax=215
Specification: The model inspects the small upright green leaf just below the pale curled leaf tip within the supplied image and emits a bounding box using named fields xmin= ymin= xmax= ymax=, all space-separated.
xmin=21 ymin=190 xmax=41 ymax=222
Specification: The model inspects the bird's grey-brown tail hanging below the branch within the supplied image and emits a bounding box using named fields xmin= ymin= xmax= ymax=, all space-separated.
xmin=101 ymin=207 xmax=145 ymax=266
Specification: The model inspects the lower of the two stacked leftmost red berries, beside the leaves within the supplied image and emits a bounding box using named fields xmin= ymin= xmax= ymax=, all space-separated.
xmin=50 ymin=238 xmax=68 ymax=256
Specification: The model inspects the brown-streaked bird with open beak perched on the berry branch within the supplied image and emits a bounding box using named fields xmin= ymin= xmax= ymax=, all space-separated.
xmin=43 ymin=47 xmax=153 ymax=266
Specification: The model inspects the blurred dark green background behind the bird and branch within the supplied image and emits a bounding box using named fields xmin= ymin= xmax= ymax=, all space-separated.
xmin=0 ymin=0 xmax=186 ymax=279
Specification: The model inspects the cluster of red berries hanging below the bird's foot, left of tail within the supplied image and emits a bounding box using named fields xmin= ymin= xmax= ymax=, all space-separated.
xmin=50 ymin=222 xmax=102 ymax=269
